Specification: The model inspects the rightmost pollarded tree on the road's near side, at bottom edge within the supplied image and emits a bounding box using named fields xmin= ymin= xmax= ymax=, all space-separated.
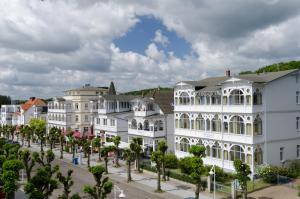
xmin=83 ymin=165 xmax=113 ymax=199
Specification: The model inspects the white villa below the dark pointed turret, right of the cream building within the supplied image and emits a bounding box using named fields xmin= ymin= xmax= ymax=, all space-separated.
xmin=91 ymin=94 xmax=133 ymax=143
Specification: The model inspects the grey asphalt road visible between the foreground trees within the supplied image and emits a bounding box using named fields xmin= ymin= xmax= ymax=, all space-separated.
xmin=51 ymin=160 xmax=163 ymax=199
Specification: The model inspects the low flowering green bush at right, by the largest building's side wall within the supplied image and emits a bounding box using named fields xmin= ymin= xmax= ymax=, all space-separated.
xmin=257 ymin=165 xmax=297 ymax=183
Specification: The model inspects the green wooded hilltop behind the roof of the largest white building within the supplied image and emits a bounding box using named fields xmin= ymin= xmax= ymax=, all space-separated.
xmin=240 ymin=61 xmax=300 ymax=75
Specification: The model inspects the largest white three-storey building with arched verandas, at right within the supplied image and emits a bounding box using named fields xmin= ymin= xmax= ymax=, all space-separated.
xmin=174 ymin=70 xmax=300 ymax=171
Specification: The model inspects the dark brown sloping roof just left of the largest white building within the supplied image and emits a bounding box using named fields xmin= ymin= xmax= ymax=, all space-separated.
xmin=146 ymin=90 xmax=174 ymax=114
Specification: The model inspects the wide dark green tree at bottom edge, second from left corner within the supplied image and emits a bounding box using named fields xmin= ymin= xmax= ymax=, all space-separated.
xmin=24 ymin=166 xmax=59 ymax=199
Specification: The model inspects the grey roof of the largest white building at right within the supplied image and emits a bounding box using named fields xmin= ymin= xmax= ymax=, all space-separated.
xmin=178 ymin=69 xmax=299 ymax=91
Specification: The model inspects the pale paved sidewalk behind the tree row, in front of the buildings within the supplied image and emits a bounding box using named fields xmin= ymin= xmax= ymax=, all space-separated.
xmin=24 ymin=143 xmax=221 ymax=199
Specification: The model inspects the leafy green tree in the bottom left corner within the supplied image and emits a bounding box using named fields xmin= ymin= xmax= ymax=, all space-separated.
xmin=2 ymin=159 xmax=24 ymax=199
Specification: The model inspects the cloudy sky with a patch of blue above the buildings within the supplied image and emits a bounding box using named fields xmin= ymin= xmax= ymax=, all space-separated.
xmin=0 ymin=0 xmax=300 ymax=99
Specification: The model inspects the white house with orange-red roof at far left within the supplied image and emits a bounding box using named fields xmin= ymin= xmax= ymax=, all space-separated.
xmin=12 ymin=97 xmax=47 ymax=125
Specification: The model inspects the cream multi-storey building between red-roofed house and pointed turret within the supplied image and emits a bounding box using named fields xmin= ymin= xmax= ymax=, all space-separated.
xmin=48 ymin=84 xmax=108 ymax=133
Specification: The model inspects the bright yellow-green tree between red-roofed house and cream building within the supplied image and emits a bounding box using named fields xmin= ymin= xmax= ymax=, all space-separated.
xmin=29 ymin=118 xmax=46 ymax=152
